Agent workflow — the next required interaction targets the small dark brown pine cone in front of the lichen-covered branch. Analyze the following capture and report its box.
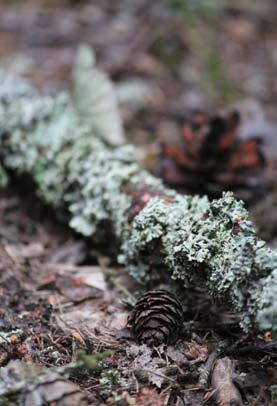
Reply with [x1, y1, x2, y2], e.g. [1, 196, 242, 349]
[128, 289, 183, 346]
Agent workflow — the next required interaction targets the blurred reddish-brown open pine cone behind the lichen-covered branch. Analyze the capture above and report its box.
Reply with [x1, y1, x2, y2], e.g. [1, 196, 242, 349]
[161, 112, 266, 200]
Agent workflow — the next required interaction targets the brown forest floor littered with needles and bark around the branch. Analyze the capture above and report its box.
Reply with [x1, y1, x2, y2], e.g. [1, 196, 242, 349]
[0, 0, 277, 406]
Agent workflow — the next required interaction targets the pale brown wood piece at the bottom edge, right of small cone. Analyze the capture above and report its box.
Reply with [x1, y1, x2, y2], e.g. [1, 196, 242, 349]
[212, 357, 240, 406]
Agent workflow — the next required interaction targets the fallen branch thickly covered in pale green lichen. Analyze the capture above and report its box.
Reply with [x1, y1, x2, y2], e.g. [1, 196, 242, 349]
[0, 46, 277, 332]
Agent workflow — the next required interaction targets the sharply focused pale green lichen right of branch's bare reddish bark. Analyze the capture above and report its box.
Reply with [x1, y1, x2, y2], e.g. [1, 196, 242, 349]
[123, 193, 277, 329]
